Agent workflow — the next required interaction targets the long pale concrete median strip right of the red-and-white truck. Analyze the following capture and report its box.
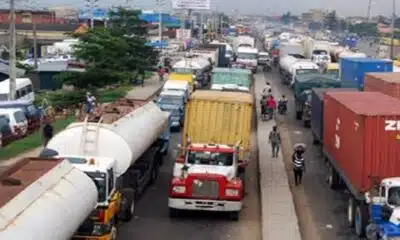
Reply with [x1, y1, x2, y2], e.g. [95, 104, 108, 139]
[255, 74, 301, 240]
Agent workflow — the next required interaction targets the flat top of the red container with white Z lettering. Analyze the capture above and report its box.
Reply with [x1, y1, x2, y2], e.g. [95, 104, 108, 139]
[326, 92, 400, 116]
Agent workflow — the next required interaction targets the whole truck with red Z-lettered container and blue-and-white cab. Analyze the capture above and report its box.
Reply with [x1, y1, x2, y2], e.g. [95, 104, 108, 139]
[323, 92, 400, 240]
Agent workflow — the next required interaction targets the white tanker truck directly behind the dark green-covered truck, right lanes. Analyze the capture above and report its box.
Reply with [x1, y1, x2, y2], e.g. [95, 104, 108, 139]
[279, 56, 320, 85]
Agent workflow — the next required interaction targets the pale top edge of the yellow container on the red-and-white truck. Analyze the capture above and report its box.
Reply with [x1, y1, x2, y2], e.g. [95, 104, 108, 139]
[190, 90, 253, 104]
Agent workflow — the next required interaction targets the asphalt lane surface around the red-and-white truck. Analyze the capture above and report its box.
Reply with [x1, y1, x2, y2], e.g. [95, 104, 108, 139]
[118, 106, 261, 240]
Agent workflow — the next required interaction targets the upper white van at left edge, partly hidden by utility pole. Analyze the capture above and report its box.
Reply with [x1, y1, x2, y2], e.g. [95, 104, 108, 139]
[0, 78, 35, 102]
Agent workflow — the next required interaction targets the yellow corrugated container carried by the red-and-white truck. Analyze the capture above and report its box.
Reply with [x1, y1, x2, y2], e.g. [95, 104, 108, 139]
[182, 90, 253, 157]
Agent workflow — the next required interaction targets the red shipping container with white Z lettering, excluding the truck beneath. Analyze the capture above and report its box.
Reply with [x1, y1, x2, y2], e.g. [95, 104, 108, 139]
[324, 92, 400, 194]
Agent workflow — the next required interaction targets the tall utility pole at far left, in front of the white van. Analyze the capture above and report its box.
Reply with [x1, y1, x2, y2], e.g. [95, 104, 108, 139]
[8, 0, 17, 100]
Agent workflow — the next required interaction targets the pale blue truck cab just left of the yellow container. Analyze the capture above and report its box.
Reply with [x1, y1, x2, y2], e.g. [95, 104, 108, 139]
[156, 90, 185, 129]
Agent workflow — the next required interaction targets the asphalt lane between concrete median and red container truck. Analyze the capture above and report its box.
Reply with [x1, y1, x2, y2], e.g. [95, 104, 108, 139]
[266, 69, 359, 240]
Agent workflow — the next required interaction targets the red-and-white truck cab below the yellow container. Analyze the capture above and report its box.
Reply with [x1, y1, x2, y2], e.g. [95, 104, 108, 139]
[168, 143, 244, 220]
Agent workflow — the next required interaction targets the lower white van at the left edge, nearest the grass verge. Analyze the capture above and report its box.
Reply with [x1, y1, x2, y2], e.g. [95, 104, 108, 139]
[0, 108, 28, 136]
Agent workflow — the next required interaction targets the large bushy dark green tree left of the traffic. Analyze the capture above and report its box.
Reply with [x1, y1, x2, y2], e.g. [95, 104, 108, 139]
[58, 8, 158, 88]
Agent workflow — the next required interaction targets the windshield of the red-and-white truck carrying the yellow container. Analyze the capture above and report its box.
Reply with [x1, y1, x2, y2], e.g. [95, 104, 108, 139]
[187, 151, 233, 166]
